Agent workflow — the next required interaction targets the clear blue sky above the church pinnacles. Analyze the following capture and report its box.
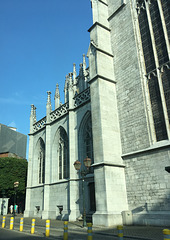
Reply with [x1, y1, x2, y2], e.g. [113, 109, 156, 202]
[0, 0, 92, 158]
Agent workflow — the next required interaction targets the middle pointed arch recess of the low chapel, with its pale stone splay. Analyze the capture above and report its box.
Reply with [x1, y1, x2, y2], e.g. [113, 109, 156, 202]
[52, 126, 69, 182]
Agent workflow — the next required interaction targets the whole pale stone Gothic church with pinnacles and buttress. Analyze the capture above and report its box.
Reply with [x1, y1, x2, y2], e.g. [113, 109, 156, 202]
[25, 0, 170, 226]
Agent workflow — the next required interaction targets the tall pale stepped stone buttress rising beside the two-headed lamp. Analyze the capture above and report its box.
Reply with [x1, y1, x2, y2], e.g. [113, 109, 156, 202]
[89, 0, 128, 226]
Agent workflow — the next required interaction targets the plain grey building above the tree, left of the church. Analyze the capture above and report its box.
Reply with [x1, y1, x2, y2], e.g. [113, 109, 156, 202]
[0, 123, 27, 158]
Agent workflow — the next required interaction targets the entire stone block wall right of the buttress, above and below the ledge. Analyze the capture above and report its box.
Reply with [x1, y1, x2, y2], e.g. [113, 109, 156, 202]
[108, 0, 170, 225]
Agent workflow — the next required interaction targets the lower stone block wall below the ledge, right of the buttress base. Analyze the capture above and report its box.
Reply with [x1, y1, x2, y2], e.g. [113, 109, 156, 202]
[124, 147, 170, 225]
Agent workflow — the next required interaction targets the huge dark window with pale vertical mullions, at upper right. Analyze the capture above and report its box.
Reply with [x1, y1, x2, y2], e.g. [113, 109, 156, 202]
[136, 0, 170, 141]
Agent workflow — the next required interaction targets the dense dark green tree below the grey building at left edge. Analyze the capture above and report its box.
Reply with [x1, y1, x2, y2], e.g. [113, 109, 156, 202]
[0, 157, 28, 212]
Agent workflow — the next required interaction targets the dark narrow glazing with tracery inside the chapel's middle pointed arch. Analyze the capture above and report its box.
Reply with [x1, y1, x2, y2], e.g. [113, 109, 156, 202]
[58, 127, 69, 179]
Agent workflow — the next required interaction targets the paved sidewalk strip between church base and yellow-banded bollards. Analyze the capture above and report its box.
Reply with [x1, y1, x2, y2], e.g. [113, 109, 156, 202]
[0, 214, 166, 240]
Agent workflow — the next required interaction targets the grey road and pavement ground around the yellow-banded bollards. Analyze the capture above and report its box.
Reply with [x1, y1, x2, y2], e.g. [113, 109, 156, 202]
[0, 215, 167, 240]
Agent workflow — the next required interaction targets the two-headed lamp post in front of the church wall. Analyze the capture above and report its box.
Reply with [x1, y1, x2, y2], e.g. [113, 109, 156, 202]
[74, 157, 91, 227]
